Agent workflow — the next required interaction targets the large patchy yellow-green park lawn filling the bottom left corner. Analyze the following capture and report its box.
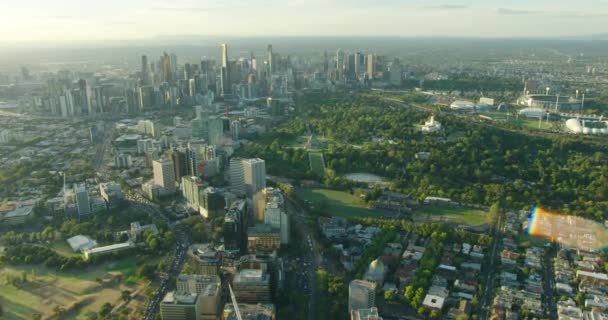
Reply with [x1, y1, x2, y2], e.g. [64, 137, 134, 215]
[0, 257, 142, 320]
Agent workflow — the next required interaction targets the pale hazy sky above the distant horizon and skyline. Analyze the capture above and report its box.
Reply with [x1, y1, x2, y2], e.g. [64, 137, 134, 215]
[0, 0, 608, 44]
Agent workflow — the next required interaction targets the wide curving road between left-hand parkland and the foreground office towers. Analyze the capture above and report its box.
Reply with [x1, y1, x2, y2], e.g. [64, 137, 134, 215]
[125, 191, 190, 320]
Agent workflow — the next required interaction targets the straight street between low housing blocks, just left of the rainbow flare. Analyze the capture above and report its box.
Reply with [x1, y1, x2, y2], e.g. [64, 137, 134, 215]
[479, 214, 505, 320]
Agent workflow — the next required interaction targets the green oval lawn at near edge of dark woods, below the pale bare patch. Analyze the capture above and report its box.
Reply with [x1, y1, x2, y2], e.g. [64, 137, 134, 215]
[296, 189, 380, 218]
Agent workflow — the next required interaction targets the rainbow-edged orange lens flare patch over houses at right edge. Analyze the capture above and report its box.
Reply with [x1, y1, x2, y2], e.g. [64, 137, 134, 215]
[526, 206, 608, 251]
